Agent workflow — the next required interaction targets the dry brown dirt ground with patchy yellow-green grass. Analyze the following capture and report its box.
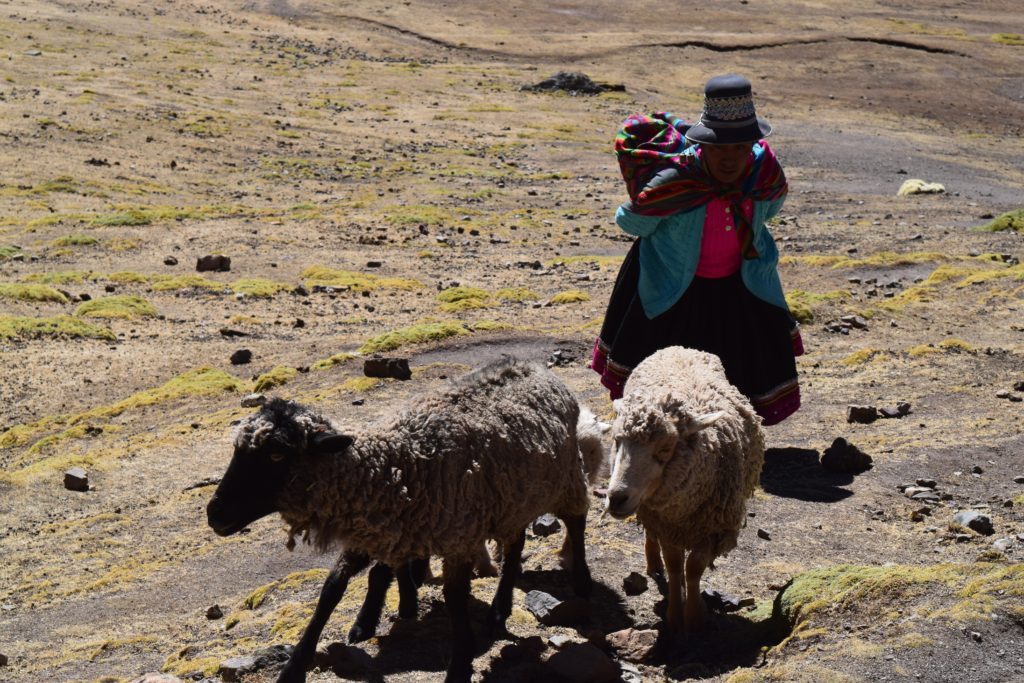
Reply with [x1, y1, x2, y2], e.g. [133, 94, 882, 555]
[0, 0, 1024, 683]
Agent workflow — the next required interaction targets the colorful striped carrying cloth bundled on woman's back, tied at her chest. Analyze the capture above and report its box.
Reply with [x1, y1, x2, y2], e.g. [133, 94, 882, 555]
[615, 112, 788, 258]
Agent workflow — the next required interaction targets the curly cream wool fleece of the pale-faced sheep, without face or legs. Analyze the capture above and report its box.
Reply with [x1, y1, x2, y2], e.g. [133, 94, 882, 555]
[615, 346, 764, 558]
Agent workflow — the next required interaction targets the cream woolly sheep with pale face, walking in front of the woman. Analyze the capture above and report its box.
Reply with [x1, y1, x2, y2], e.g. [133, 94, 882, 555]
[607, 346, 764, 632]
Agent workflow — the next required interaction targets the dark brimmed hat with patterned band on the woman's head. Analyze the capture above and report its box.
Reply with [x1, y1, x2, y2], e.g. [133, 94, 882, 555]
[686, 74, 771, 144]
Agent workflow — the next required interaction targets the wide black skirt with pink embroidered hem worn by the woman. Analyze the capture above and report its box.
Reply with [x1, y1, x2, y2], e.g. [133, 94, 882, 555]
[591, 240, 803, 425]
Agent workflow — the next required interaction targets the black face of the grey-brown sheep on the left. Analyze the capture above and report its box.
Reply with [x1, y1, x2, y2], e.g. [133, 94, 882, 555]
[206, 442, 289, 536]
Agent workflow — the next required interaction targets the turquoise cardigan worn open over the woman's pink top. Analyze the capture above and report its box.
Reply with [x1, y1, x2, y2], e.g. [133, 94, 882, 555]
[615, 197, 790, 318]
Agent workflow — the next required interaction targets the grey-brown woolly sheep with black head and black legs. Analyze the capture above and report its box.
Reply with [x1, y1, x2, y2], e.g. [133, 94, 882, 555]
[207, 357, 591, 682]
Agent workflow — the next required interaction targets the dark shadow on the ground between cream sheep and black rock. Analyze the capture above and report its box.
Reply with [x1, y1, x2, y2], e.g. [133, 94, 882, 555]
[761, 446, 853, 503]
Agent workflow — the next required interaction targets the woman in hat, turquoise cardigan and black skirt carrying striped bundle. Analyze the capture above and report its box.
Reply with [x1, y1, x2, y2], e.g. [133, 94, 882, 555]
[591, 75, 803, 425]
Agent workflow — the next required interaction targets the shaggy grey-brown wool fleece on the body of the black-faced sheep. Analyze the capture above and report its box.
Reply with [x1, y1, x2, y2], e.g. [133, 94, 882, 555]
[279, 358, 588, 565]
